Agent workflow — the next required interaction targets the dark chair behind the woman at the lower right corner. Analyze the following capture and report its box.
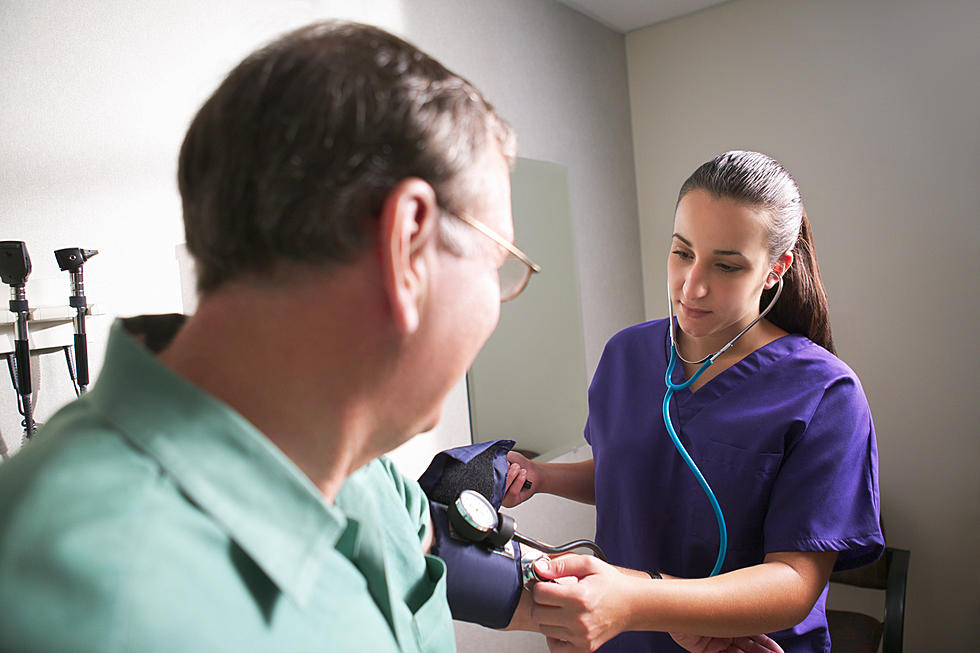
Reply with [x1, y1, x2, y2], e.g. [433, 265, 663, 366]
[827, 547, 911, 653]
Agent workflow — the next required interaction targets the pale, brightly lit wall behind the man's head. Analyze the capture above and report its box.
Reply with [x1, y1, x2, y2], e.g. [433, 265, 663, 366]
[0, 0, 642, 450]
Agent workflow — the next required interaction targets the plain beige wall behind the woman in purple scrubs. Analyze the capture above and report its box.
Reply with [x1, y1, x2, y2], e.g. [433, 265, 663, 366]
[627, 0, 980, 651]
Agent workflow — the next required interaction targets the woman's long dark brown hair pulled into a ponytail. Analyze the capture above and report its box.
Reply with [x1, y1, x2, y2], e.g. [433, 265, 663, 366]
[677, 150, 836, 353]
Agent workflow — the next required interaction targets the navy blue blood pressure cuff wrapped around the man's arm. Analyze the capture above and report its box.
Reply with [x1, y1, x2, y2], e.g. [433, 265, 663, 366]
[419, 440, 522, 628]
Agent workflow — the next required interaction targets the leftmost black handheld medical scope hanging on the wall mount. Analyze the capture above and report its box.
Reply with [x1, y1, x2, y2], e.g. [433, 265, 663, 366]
[0, 240, 34, 438]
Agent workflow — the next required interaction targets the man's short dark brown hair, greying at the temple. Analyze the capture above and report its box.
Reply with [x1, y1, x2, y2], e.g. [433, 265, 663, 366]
[177, 21, 516, 293]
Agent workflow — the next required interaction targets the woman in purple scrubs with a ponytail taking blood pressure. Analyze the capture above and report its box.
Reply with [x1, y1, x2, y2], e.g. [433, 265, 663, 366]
[504, 151, 884, 653]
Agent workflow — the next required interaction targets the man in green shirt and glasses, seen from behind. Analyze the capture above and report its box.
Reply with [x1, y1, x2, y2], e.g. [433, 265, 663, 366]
[0, 23, 530, 653]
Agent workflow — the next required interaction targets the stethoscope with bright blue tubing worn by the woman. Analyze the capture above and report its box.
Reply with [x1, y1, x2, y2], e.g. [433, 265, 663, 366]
[663, 275, 783, 576]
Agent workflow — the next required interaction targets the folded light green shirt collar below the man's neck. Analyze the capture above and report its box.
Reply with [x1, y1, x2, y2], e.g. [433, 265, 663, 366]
[85, 316, 347, 607]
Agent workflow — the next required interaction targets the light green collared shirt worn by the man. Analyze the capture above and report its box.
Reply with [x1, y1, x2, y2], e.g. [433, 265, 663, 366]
[0, 318, 455, 653]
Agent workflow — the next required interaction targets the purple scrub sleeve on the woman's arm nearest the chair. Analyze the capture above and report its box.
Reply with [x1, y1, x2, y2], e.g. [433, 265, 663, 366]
[765, 377, 884, 571]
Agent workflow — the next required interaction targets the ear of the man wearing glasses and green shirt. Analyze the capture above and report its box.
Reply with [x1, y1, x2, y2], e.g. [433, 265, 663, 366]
[378, 177, 442, 334]
